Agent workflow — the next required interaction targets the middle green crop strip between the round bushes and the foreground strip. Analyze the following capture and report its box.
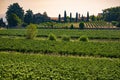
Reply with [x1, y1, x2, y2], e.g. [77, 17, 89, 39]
[0, 38, 120, 58]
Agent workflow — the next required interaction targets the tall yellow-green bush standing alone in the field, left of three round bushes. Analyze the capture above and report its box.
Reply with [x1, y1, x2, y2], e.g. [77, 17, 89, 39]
[26, 24, 37, 39]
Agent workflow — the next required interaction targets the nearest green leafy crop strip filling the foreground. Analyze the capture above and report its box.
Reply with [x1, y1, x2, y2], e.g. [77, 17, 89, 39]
[0, 52, 120, 80]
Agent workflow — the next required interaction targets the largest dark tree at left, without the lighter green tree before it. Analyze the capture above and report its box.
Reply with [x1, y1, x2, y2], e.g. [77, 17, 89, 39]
[6, 3, 24, 27]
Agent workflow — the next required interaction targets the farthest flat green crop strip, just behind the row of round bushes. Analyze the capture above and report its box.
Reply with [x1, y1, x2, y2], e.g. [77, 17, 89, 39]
[0, 29, 120, 39]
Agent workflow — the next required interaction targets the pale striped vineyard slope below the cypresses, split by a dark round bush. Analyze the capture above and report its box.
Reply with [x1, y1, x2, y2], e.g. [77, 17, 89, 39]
[38, 21, 117, 29]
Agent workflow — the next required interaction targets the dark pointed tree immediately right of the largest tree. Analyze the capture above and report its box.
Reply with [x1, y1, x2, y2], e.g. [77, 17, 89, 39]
[24, 9, 33, 24]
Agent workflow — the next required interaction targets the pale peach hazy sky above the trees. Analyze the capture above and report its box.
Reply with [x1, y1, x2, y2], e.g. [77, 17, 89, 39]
[0, 0, 120, 17]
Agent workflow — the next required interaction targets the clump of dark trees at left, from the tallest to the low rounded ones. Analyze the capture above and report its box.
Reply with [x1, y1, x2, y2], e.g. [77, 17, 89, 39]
[6, 3, 50, 27]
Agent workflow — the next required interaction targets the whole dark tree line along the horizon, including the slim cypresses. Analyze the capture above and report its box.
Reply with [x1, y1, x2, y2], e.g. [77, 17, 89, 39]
[0, 3, 120, 28]
